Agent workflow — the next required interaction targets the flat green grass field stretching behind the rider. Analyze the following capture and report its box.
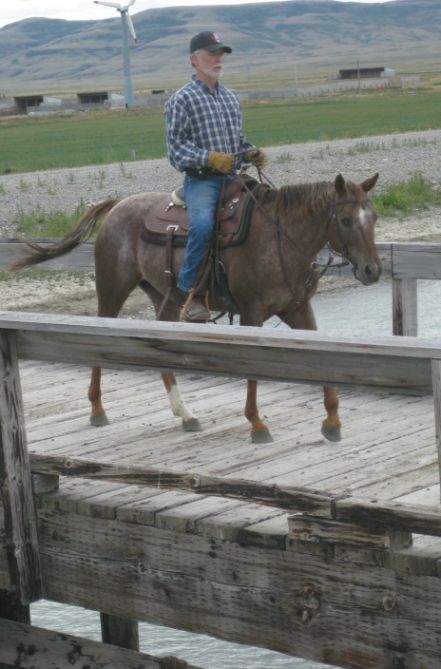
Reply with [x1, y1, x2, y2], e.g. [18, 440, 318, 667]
[0, 89, 441, 174]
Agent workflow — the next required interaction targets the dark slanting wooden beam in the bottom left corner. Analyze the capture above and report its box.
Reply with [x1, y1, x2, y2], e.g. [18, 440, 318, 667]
[0, 620, 203, 669]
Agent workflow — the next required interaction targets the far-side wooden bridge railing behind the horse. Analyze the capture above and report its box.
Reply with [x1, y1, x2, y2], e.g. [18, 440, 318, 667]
[0, 239, 441, 337]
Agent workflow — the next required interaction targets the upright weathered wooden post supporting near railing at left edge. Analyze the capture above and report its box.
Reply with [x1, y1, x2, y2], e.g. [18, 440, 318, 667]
[0, 330, 41, 605]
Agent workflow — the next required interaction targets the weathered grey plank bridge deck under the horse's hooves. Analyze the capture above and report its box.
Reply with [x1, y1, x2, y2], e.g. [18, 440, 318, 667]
[20, 361, 440, 506]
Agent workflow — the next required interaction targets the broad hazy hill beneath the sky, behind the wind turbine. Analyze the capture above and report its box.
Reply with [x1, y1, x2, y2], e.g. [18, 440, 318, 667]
[0, 0, 441, 95]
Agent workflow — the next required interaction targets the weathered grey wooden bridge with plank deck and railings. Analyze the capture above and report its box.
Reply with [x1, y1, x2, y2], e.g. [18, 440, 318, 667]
[0, 244, 441, 669]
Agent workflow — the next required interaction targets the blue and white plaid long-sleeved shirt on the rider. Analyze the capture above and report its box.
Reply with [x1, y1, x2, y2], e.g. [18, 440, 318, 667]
[165, 75, 253, 172]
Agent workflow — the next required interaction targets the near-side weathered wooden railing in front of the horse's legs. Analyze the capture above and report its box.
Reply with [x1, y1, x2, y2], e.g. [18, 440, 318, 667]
[0, 311, 441, 668]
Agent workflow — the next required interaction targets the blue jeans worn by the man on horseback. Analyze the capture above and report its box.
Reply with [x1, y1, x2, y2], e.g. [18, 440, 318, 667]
[178, 175, 234, 292]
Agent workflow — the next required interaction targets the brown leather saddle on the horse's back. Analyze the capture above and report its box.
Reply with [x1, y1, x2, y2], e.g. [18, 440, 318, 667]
[140, 174, 268, 317]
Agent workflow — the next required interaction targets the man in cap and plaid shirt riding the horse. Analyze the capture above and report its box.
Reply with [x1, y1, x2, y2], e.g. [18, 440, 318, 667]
[165, 31, 266, 321]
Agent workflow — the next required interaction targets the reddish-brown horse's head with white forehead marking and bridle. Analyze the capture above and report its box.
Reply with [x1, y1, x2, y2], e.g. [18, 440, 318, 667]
[327, 174, 383, 286]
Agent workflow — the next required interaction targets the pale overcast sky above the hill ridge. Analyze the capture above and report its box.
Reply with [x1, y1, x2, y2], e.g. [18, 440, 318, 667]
[0, 0, 393, 27]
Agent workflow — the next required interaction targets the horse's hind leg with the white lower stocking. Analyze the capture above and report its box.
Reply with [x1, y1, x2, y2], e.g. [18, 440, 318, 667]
[139, 281, 202, 432]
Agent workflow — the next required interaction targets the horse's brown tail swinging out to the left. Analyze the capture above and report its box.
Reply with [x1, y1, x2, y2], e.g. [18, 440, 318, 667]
[8, 199, 120, 272]
